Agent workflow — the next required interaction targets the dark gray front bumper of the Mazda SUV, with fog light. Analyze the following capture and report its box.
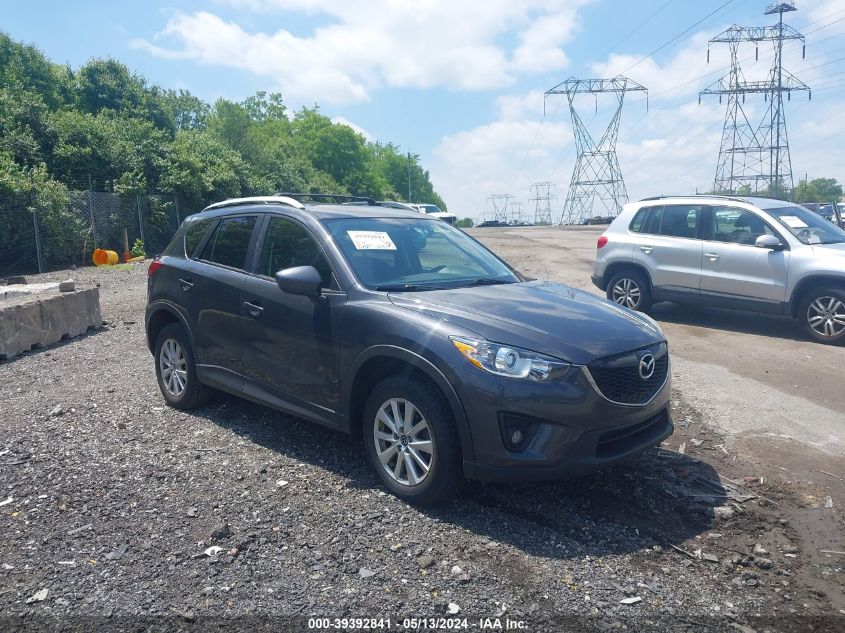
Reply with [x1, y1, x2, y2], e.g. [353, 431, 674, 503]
[458, 356, 674, 481]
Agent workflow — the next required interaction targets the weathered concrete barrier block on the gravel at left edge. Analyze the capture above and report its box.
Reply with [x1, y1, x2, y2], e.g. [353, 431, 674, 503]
[0, 288, 103, 360]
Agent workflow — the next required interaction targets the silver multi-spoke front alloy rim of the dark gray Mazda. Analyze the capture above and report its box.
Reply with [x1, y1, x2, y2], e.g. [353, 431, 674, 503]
[373, 398, 434, 486]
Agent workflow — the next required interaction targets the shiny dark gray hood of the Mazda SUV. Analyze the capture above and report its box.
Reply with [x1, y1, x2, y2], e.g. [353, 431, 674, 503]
[389, 281, 665, 365]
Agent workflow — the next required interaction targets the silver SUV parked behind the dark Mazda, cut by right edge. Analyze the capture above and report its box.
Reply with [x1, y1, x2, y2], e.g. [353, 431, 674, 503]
[592, 196, 845, 343]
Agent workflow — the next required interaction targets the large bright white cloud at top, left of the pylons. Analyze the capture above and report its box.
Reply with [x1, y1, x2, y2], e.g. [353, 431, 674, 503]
[132, 0, 590, 103]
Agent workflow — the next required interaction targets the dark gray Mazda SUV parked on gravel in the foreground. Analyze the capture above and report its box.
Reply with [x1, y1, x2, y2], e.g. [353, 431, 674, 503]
[146, 196, 673, 503]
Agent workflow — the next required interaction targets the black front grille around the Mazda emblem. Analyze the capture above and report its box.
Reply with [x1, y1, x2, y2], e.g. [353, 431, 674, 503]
[587, 343, 669, 405]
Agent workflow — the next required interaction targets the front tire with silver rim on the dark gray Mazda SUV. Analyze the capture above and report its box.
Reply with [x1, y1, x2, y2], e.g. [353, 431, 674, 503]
[362, 376, 464, 505]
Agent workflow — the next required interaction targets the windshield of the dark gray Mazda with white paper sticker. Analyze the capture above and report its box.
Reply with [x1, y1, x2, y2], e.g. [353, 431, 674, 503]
[323, 218, 521, 291]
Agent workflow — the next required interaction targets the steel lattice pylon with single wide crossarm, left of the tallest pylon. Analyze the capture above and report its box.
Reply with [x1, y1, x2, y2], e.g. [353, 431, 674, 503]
[543, 75, 648, 224]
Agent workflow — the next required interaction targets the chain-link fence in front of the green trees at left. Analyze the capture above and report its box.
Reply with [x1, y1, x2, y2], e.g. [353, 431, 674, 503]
[0, 185, 184, 278]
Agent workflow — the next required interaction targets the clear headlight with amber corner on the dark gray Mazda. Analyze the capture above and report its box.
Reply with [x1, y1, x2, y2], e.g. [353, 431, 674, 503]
[449, 336, 569, 382]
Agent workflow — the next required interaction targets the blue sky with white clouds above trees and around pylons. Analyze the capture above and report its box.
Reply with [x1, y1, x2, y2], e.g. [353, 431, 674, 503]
[0, 0, 845, 217]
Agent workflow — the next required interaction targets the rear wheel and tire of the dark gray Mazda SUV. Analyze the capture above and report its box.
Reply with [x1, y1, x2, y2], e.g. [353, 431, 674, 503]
[155, 323, 214, 409]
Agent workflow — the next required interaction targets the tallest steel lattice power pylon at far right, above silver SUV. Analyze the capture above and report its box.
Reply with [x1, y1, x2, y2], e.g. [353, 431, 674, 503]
[698, 0, 812, 198]
